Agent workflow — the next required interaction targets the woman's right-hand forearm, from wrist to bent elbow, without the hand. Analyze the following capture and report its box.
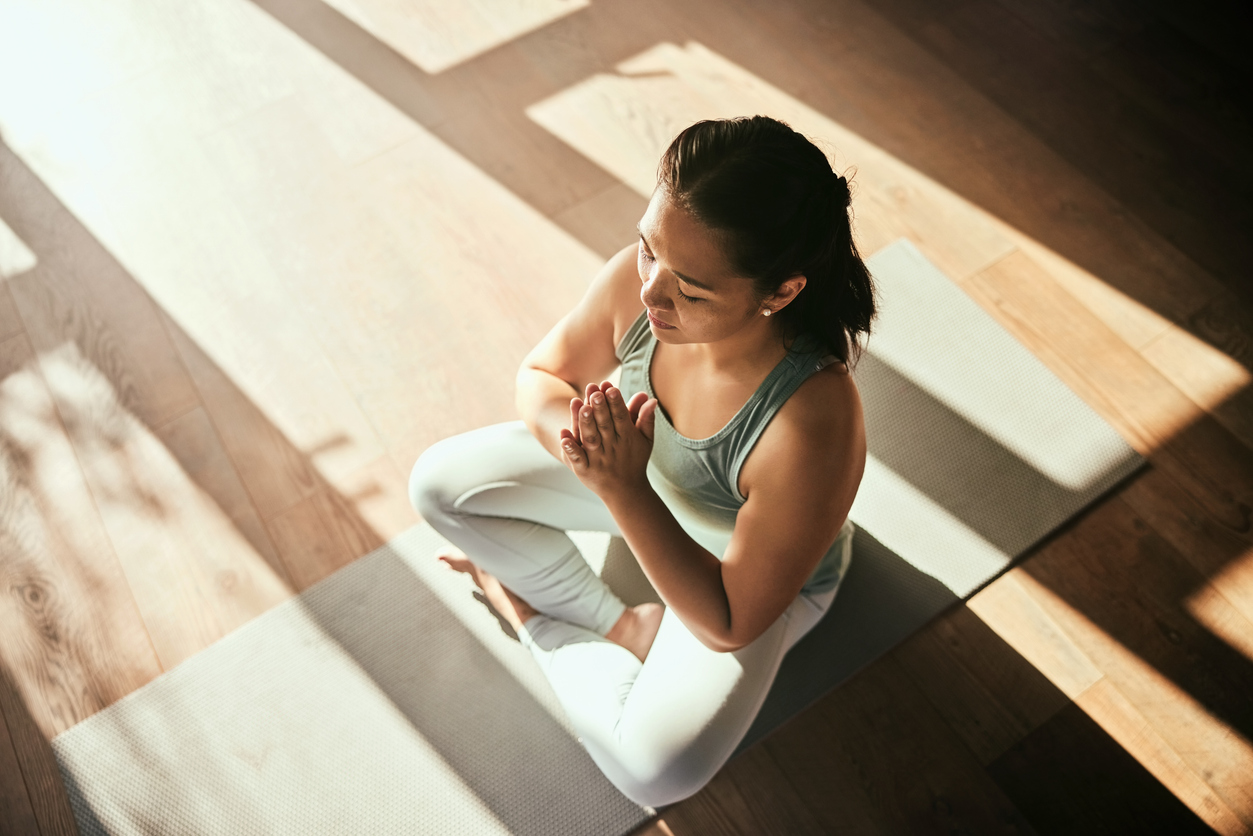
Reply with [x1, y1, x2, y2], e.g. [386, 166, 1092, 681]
[604, 483, 741, 652]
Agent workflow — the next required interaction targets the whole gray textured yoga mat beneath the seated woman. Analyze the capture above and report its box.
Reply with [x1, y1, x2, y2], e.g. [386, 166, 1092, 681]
[53, 241, 1143, 836]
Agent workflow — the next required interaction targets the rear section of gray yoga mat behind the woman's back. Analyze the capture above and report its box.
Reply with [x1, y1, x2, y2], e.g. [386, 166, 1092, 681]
[739, 239, 1144, 751]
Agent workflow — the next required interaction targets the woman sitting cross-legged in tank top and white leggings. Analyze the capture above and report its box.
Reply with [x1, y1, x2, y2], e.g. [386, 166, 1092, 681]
[410, 117, 875, 806]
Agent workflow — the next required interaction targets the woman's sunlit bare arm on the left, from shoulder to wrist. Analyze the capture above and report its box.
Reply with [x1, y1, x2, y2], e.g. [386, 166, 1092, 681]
[515, 244, 644, 459]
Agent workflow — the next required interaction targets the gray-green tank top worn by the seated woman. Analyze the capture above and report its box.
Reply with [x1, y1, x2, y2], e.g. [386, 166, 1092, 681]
[616, 312, 855, 594]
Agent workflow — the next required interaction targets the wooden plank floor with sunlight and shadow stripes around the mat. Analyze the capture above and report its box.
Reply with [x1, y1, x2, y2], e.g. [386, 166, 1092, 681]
[0, 0, 1253, 836]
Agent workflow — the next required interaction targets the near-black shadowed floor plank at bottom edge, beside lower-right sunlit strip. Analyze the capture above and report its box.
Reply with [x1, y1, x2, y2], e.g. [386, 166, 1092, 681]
[987, 704, 1213, 836]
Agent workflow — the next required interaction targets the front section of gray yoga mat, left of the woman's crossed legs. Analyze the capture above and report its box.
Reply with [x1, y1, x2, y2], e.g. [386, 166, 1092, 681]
[53, 525, 648, 836]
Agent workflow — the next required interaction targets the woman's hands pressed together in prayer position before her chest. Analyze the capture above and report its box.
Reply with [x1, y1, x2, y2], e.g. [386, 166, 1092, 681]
[561, 381, 657, 499]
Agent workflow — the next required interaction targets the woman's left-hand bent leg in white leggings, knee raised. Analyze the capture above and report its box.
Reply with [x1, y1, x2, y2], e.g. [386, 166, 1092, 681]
[408, 421, 625, 635]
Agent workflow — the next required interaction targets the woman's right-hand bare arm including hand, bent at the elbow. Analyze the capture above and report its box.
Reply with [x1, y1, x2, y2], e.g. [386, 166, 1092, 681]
[566, 372, 865, 652]
